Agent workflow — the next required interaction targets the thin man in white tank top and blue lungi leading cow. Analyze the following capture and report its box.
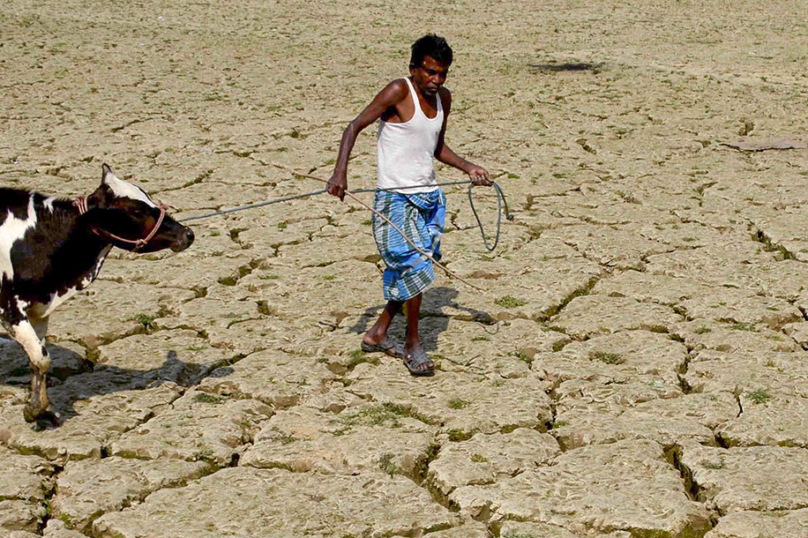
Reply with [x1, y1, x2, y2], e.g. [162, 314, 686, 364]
[328, 34, 491, 375]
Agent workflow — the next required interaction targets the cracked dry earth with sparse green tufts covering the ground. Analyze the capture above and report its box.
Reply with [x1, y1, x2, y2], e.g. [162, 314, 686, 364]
[0, 0, 808, 538]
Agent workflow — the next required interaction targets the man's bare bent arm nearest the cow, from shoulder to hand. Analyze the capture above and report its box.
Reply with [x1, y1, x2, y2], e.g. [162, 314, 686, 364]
[328, 80, 409, 200]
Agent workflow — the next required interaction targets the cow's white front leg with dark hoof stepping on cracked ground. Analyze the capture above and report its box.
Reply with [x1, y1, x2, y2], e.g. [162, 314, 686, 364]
[3, 301, 52, 422]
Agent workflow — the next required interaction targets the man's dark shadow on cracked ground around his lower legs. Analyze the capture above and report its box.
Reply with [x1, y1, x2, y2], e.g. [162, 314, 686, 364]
[349, 286, 494, 351]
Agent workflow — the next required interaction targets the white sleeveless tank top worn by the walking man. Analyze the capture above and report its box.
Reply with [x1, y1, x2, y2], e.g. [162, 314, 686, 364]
[376, 79, 443, 194]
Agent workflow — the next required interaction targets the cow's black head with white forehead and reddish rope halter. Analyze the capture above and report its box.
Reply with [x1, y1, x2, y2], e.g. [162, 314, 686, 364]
[87, 164, 194, 252]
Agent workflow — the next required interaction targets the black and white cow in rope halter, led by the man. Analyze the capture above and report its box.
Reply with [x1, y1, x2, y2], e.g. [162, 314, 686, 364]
[0, 163, 194, 424]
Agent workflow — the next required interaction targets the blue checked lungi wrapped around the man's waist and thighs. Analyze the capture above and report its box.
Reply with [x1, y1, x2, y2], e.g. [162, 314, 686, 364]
[372, 189, 446, 301]
